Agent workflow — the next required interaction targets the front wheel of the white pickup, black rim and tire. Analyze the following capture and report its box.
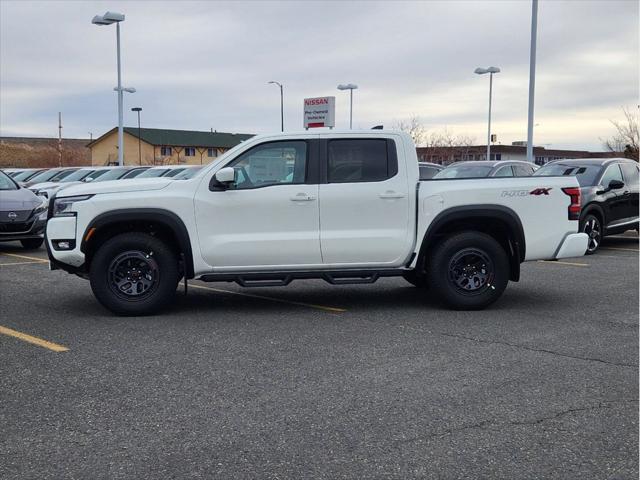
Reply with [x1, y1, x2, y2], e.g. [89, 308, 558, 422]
[89, 232, 179, 316]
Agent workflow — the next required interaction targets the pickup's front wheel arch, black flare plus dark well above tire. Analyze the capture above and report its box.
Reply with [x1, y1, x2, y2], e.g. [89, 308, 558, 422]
[80, 208, 194, 278]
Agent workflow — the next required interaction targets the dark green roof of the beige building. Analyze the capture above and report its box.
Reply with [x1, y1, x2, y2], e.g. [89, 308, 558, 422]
[87, 127, 253, 148]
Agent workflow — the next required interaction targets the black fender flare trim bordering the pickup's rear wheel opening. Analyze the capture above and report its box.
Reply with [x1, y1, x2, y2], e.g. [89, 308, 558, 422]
[419, 204, 526, 281]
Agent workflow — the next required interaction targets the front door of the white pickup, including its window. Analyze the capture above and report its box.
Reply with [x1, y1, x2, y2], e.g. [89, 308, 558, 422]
[195, 139, 322, 270]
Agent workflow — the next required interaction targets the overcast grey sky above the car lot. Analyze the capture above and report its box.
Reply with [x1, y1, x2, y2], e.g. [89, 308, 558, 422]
[0, 0, 639, 150]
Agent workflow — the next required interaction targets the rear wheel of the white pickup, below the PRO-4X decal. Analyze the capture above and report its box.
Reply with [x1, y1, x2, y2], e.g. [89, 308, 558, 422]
[427, 231, 509, 310]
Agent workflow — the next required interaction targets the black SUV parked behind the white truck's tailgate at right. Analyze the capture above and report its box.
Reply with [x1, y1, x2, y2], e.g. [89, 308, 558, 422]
[534, 158, 640, 255]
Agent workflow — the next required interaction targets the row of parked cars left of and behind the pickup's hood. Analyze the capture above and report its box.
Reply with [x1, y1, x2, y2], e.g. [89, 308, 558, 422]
[0, 165, 202, 249]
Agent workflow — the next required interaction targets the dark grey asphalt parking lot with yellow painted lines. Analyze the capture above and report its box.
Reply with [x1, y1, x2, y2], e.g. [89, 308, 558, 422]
[0, 234, 638, 479]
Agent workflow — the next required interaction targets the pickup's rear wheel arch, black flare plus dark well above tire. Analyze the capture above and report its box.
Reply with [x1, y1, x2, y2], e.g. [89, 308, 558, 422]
[417, 205, 526, 281]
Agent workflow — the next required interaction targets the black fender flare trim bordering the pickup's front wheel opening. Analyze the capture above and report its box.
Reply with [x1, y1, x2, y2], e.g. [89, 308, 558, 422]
[80, 208, 194, 278]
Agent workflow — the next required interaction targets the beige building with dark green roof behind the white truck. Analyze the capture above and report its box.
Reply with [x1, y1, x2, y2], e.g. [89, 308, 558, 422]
[87, 127, 253, 166]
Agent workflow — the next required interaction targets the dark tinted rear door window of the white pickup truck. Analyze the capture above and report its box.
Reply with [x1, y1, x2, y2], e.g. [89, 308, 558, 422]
[327, 139, 398, 183]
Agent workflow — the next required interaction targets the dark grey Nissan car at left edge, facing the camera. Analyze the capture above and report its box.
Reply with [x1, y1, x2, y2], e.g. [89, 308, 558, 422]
[0, 171, 48, 249]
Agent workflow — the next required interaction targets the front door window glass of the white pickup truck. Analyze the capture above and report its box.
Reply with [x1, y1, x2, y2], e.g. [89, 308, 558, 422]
[227, 141, 307, 190]
